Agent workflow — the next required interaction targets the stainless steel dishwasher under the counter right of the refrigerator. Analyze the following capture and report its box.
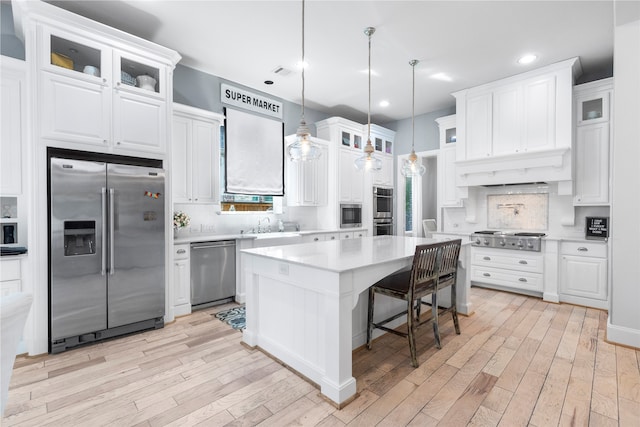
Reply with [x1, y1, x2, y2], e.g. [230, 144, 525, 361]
[191, 240, 236, 310]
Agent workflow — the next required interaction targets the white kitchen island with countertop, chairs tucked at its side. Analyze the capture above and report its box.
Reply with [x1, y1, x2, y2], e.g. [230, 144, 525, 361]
[242, 236, 470, 406]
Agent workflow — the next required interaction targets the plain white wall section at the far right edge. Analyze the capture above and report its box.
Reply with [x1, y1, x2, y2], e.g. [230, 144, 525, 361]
[607, 11, 640, 348]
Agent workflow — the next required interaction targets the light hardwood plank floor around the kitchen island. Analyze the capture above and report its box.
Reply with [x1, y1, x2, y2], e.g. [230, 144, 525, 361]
[0, 288, 640, 427]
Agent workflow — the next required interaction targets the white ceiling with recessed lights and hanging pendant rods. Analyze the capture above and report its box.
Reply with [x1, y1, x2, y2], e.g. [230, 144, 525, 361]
[43, 0, 614, 124]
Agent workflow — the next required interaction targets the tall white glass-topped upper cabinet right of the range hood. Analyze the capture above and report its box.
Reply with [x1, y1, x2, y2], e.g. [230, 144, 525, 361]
[573, 79, 613, 206]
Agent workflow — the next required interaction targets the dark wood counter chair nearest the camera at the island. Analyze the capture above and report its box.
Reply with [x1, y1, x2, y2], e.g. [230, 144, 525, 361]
[367, 243, 442, 368]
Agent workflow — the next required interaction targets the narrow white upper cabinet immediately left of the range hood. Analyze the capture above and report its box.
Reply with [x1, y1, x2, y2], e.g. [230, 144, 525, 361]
[436, 114, 462, 207]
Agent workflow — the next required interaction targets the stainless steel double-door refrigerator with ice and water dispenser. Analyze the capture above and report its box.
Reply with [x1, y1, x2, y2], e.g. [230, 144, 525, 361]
[49, 156, 165, 353]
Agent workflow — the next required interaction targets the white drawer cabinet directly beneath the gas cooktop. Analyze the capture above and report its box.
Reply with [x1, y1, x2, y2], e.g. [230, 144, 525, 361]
[471, 247, 544, 295]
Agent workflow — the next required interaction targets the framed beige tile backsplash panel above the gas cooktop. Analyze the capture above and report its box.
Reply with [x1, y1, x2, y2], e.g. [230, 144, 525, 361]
[487, 193, 549, 230]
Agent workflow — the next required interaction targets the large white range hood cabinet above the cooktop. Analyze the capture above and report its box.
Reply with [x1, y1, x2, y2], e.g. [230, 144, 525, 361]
[454, 58, 578, 186]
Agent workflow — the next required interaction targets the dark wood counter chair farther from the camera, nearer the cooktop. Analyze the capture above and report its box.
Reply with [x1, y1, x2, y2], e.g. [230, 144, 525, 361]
[416, 239, 462, 348]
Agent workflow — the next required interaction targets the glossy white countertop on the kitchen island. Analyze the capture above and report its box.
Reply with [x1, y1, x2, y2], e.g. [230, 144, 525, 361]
[242, 236, 464, 273]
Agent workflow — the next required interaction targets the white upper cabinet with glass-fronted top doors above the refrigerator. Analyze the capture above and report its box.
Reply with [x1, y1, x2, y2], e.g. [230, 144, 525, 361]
[14, 2, 180, 157]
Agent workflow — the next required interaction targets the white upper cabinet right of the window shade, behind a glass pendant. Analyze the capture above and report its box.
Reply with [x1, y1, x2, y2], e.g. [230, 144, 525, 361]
[285, 135, 329, 206]
